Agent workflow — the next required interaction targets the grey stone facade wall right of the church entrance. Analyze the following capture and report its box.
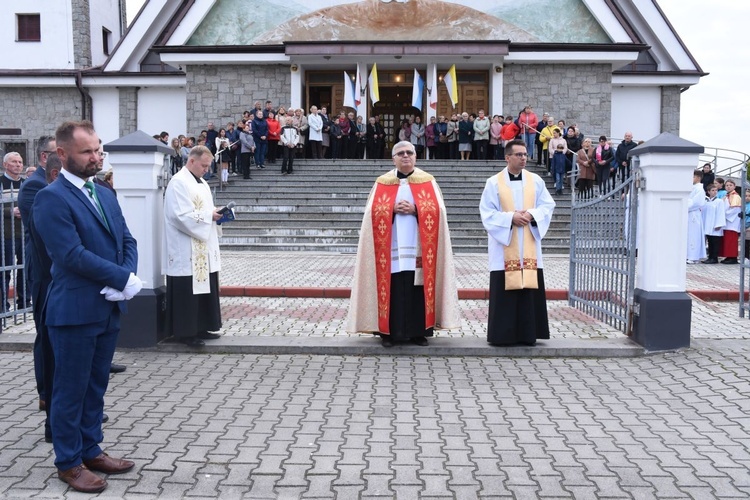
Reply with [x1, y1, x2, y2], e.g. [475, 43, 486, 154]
[503, 64, 612, 136]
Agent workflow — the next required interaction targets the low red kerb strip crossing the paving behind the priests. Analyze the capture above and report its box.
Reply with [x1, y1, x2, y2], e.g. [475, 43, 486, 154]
[219, 285, 750, 302]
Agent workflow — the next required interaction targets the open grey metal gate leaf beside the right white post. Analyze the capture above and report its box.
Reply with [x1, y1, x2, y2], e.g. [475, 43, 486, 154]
[568, 166, 640, 335]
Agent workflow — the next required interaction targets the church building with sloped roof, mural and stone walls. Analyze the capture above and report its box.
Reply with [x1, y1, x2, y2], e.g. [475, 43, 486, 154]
[0, 0, 705, 164]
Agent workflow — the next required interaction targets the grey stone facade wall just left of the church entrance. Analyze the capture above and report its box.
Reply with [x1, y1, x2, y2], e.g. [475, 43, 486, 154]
[185, 65, 291, 135]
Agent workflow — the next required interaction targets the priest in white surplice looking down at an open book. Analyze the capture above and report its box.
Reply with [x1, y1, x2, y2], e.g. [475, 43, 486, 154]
[162, 146, 221, 347]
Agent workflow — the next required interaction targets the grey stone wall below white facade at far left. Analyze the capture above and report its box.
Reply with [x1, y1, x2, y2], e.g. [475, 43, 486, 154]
[0, 87, 83, 165]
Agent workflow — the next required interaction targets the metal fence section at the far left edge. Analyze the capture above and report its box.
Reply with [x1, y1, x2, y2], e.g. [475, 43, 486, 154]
[0, 188, 31, 327]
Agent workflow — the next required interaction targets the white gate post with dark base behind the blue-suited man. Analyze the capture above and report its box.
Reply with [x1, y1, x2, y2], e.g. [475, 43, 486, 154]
[104, 130, 172, 347]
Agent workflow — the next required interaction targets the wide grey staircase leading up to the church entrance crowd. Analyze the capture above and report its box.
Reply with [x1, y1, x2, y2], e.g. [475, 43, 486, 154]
[210, 160, 571, 254]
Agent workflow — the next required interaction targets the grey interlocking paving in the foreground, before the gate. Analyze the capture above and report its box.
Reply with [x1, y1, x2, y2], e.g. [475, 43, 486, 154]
[0, 340, 750, 499]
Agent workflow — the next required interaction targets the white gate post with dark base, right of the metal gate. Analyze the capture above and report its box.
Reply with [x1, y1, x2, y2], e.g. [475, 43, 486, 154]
[628, 132, 703, 351]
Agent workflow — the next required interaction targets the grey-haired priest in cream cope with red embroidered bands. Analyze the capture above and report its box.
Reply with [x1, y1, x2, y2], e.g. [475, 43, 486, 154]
[347, 141, 461, 347]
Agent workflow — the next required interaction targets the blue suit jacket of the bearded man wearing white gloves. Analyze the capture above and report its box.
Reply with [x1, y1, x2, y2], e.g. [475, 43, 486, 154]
[33, 175, 138, 326]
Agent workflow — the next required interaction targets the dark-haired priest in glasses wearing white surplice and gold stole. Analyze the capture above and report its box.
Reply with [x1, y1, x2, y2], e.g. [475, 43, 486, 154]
[479, 140, 555, 345]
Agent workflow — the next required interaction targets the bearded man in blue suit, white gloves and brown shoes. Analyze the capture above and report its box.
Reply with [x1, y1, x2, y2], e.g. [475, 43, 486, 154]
[33, 121, 142, 493]
